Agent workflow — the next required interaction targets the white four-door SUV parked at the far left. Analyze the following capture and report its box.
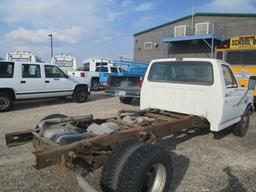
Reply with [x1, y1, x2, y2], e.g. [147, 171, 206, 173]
[0, 61, 90, 112]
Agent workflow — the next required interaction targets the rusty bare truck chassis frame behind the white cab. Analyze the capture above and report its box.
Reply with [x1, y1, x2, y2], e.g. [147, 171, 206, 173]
[6, 109, 209, 191]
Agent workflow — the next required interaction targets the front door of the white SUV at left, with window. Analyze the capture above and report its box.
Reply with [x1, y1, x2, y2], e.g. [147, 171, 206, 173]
[44, 65, 75, 96]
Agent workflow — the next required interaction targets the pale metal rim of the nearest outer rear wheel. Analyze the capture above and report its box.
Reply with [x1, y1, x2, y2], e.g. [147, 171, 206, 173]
[141, 163, 166, 192]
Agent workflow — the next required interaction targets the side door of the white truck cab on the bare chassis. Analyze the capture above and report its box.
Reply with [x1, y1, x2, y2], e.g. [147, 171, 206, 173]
[222, 64, 245, 123]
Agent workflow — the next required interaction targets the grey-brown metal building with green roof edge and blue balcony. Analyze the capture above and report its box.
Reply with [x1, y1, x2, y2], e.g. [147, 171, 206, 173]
[134, 13, 256, 61]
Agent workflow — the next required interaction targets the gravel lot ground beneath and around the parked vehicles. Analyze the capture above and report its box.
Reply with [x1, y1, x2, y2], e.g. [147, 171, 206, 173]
[0, 92, 256, 192]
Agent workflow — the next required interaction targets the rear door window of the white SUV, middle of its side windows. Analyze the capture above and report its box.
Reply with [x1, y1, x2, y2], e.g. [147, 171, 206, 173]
[21, 64, 41, 78]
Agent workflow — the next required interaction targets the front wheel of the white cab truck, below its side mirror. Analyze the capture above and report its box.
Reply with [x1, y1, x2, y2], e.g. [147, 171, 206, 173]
[233, 107, 250, 137]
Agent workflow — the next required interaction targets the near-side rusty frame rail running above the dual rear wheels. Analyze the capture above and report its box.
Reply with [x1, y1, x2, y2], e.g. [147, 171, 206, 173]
[34, 116, 207, 169]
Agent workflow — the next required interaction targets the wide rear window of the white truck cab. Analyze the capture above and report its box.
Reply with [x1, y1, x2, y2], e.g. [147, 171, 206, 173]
[148, 61, 213, 85]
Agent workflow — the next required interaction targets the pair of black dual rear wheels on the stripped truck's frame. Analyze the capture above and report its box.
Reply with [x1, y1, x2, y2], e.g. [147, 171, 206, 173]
[101, 141, 172, 192]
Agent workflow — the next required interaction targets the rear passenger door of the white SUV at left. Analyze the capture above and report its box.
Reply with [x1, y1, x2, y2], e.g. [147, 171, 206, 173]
[17, 64, 45, 98]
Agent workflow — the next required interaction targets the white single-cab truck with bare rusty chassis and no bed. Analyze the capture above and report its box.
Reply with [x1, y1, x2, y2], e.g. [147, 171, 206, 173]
[6, 58, 256, 192]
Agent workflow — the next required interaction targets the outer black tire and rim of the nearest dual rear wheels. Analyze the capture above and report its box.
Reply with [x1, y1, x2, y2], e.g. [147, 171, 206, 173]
[117, 144, 172, 192]
